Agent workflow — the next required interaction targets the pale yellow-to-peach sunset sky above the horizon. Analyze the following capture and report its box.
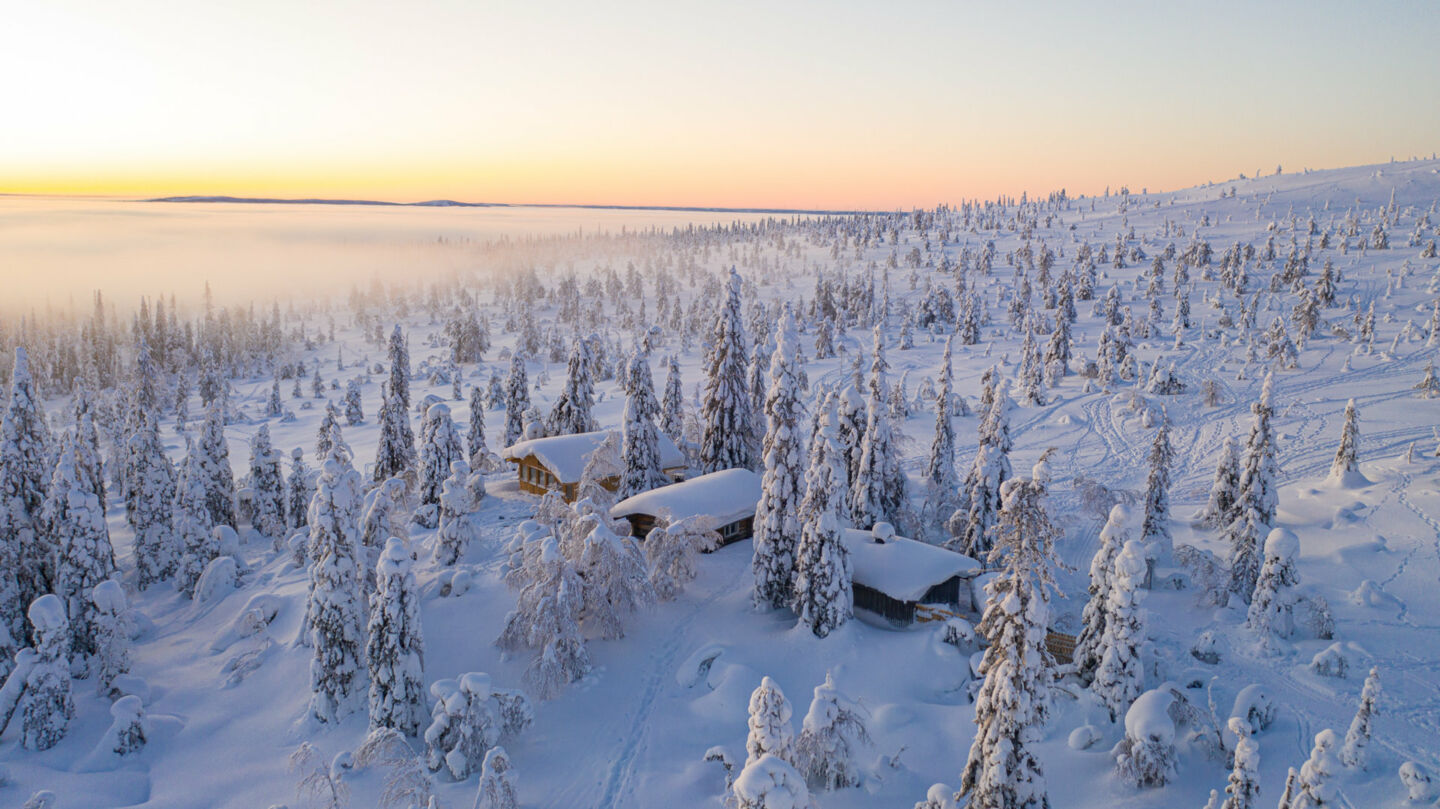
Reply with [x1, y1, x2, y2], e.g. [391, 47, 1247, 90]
[0, 0, 1440, 209]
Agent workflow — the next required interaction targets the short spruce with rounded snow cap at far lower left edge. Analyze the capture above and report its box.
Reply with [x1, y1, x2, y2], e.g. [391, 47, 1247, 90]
[19, 595, 75, 750]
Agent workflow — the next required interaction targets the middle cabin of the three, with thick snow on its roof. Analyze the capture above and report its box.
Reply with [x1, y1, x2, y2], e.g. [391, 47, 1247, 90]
[611, 469, 760, 546]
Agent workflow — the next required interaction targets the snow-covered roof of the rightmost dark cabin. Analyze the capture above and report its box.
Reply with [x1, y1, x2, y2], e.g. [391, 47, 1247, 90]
[840, 528, 981, 602]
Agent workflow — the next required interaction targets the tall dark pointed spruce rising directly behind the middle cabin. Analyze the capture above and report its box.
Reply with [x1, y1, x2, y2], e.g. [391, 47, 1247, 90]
[700, 268, 755, 472]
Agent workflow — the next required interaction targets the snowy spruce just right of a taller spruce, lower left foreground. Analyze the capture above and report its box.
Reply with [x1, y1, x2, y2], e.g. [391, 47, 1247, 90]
[366, 537, 425, 736]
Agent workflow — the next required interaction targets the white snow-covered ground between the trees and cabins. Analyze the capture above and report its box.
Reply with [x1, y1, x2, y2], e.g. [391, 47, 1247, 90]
[0, 160, 1440, 809]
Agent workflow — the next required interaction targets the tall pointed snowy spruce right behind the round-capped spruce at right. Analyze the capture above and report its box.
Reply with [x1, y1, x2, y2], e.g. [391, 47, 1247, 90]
[1225, 371, 1279, 599]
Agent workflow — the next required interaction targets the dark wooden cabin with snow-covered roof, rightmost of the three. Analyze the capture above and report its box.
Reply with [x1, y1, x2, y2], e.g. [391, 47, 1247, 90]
[841, 523, 981, 623]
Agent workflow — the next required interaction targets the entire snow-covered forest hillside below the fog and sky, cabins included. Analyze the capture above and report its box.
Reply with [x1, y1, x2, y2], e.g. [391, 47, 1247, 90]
[0, 158, 1440, 809]
